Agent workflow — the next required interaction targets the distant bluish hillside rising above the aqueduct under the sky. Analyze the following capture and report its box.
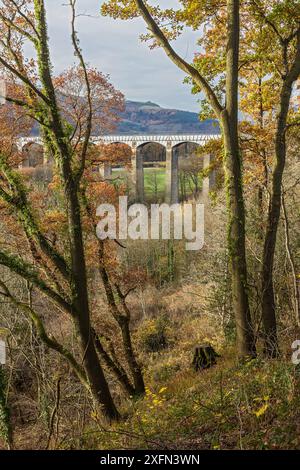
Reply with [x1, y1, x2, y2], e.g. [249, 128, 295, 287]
[115, 101, 219, 134]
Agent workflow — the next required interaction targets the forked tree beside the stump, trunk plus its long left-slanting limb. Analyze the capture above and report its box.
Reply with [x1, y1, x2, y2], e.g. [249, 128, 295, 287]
[135, 0, 256, 357]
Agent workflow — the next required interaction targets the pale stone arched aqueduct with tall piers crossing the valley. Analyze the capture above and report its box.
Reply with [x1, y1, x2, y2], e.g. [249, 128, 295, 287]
[18, 134, 219, 203]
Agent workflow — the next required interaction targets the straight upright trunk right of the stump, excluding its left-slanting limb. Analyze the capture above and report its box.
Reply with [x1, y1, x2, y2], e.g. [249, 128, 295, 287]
[221, 0, 255, 357]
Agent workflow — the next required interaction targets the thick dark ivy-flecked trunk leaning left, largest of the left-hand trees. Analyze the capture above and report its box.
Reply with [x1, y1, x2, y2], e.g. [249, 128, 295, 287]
[34, 0, 119, 420]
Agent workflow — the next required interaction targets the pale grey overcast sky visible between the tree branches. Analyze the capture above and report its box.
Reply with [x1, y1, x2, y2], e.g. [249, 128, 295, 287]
[46, 0, 198, 111]
